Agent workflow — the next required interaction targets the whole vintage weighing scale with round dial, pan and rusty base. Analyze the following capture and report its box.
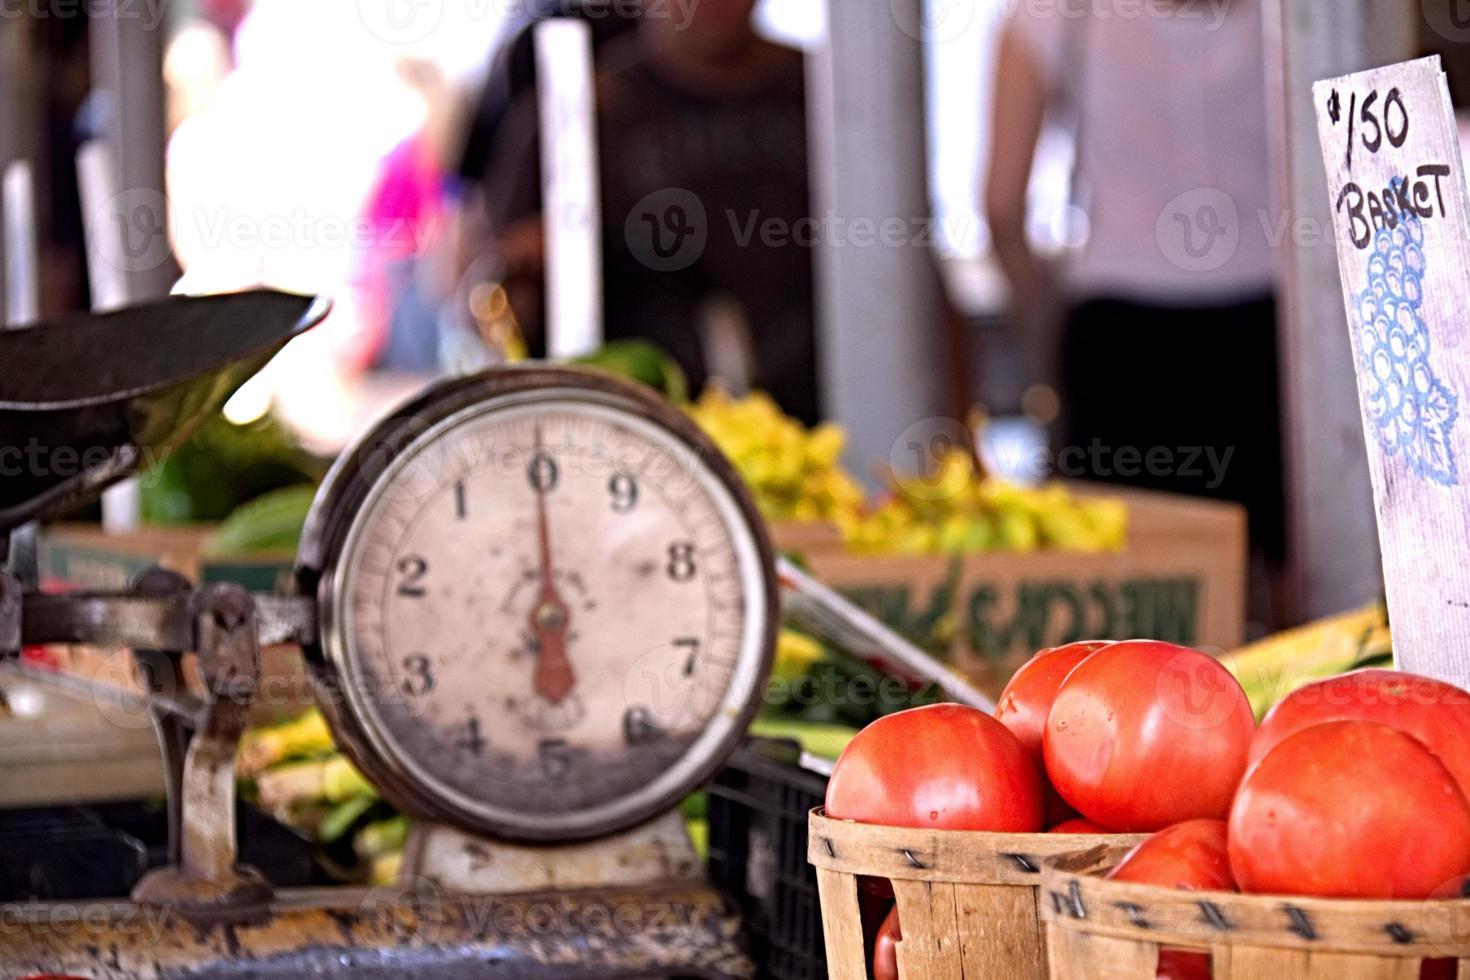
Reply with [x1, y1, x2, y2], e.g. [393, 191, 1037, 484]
[0, 291, 973, 977]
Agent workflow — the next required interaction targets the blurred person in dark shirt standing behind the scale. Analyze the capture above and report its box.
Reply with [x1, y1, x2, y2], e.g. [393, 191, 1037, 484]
[484, 0, 819, 422]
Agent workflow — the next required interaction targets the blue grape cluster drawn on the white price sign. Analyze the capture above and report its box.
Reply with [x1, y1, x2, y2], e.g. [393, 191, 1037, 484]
[1357, 181, 1460, 486]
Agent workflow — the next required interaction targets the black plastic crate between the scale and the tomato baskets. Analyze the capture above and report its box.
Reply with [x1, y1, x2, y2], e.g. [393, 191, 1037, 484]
[709, 739, 828, 980]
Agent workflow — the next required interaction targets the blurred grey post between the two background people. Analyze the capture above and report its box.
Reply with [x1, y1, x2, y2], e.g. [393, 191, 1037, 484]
[807, 0, 942, 473]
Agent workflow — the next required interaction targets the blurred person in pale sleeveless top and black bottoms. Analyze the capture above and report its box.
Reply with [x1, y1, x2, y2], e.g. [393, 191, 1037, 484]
[985, 0, 1285, 581]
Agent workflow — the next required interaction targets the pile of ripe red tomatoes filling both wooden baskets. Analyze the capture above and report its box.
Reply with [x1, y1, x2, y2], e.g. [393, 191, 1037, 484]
[826, 641, 1470, 980]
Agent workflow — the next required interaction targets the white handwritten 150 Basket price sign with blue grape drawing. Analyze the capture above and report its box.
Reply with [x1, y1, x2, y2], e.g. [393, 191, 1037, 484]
[1313, 57, 1470, 686]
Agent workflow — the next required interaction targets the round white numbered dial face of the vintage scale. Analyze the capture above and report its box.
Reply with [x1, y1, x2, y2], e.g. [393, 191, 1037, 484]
[316, 388, 772, 839]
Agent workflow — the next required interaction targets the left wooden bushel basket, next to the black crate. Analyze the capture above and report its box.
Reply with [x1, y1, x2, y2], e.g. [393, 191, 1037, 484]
[807, 808, 1152, 980]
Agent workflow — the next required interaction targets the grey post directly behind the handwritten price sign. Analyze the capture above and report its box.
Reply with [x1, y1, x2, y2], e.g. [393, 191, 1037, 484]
[1266, 0, 1419, 620]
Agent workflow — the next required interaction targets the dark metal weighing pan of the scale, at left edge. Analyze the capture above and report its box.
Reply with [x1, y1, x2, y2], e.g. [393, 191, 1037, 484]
[0, 289, 331, 537]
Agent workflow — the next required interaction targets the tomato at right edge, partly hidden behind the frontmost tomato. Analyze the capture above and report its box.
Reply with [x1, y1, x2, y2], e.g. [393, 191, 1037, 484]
[1251, 670, 1470, 798]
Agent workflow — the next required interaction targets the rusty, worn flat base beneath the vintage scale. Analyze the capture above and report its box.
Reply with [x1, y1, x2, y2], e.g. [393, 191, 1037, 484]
[0, 883, 756, 980]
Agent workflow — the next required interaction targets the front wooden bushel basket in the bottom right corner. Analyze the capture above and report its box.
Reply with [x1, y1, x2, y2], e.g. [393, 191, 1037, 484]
[1042, 846, 1470, 980]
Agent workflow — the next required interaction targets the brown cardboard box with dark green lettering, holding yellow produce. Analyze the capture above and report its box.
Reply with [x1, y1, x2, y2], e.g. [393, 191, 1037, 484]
[775, 488, 1247, 695]
